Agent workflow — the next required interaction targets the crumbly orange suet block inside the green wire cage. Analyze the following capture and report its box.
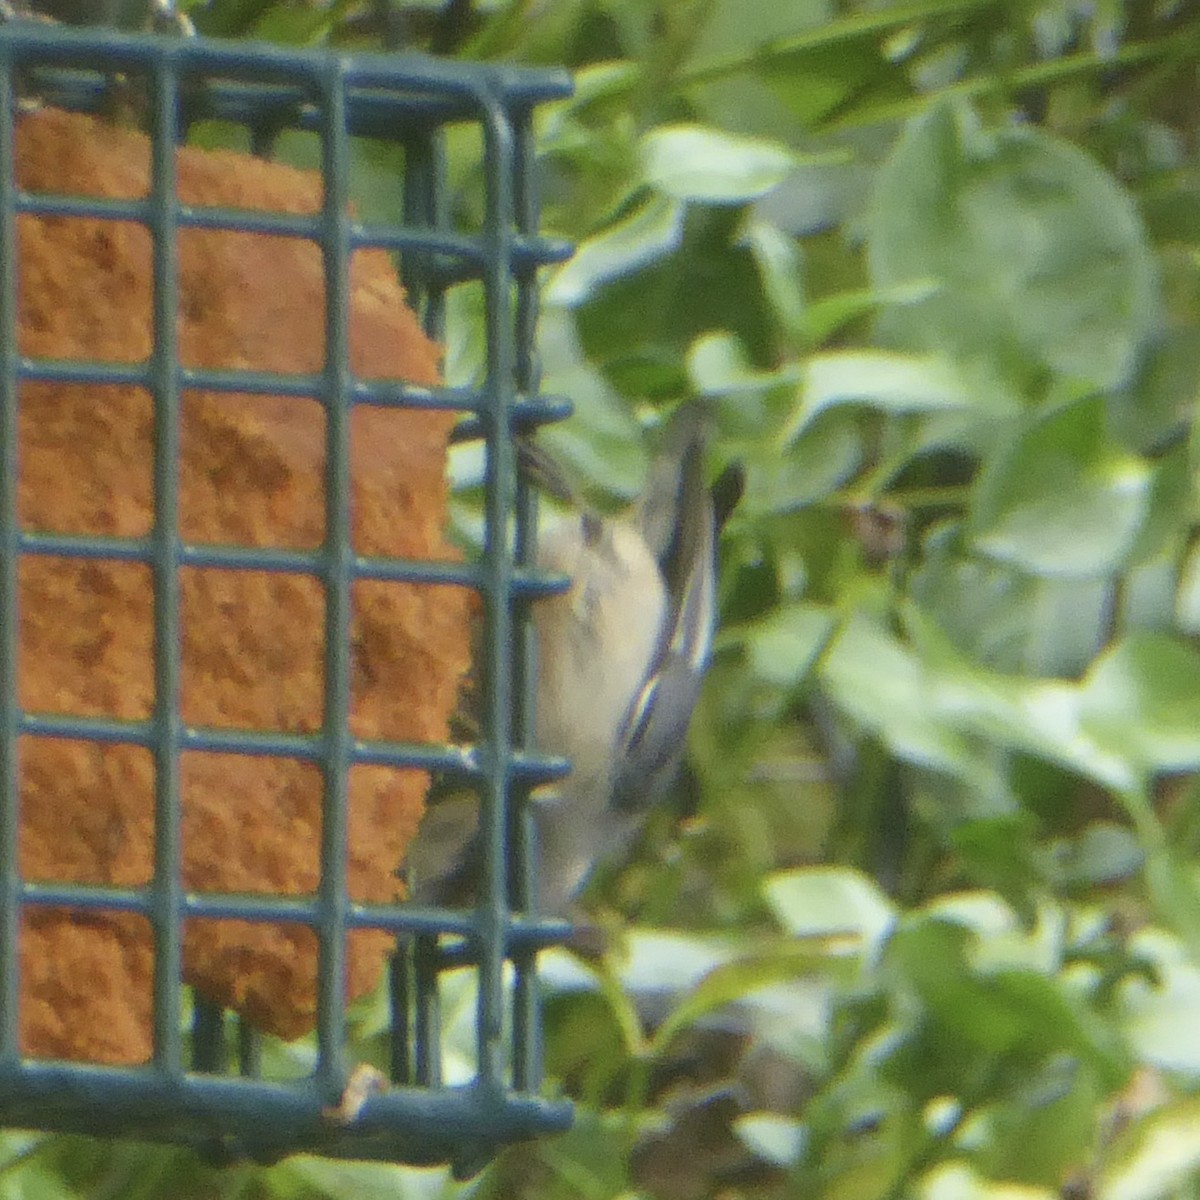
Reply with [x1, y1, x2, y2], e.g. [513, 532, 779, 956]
[16, 109, 470, 1062]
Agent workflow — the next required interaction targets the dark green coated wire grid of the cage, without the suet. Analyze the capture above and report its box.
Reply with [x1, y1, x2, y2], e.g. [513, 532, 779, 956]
[0, 14, 570, 1175]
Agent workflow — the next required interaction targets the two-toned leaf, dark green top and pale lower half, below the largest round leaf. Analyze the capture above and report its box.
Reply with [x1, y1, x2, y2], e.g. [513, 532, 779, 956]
[968, 398, 1154, 577]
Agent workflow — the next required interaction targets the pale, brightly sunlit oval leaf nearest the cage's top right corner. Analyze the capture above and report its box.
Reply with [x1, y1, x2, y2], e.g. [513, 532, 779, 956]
[640, 125, 802, 204]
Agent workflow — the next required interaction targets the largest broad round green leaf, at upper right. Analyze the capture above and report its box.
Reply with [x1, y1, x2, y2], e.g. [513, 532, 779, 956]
[869, 104, 1158, 389]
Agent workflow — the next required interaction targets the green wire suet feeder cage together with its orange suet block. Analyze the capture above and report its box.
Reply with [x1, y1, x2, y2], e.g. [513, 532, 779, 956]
[0, 4, 570, 1175]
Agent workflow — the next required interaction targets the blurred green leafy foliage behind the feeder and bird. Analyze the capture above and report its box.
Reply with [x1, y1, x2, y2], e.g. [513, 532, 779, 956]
[11, 0, 1200, 1200]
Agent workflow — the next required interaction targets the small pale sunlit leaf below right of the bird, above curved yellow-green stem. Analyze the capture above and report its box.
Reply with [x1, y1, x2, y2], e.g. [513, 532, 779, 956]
[763, 866, 896, 953]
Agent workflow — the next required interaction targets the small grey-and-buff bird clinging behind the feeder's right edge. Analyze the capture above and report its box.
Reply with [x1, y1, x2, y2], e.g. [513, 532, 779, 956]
[409, 404, 743, 917]
